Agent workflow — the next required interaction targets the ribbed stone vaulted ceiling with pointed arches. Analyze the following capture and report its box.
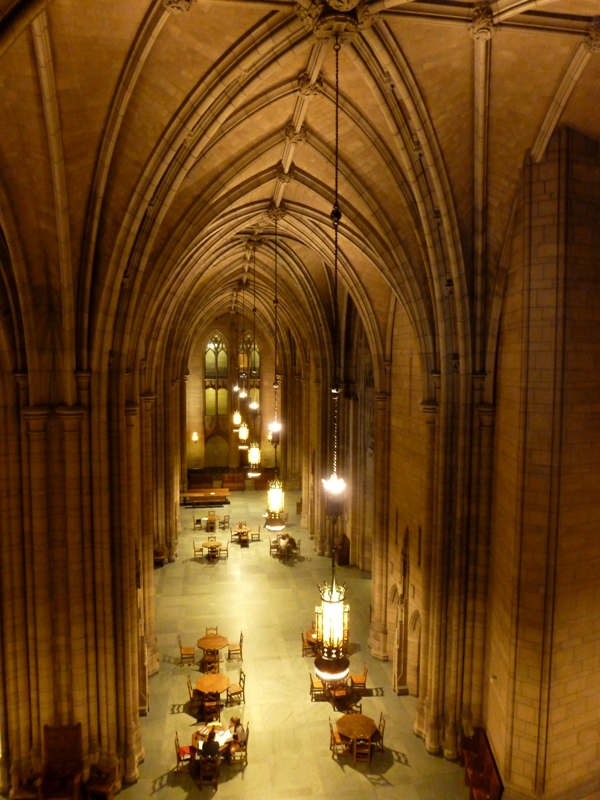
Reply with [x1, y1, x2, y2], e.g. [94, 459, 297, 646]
[0, 0, 600, 394]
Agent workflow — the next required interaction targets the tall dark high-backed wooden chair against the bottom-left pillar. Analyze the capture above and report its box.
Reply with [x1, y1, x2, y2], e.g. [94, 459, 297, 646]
[38, 722, 83, 800]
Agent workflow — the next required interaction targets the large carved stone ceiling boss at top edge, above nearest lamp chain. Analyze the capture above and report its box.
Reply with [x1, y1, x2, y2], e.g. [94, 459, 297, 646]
[296, 0, 376, 41]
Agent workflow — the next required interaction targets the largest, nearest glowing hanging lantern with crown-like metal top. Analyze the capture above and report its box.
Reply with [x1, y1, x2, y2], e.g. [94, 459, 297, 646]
[315, 569, 350, 681]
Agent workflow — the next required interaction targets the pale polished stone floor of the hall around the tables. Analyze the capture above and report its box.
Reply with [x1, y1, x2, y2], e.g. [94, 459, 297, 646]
[122, 491, 468, 800]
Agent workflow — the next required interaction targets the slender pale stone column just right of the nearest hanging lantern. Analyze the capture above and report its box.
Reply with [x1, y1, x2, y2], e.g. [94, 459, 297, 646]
[369, 392, 390, 661]
